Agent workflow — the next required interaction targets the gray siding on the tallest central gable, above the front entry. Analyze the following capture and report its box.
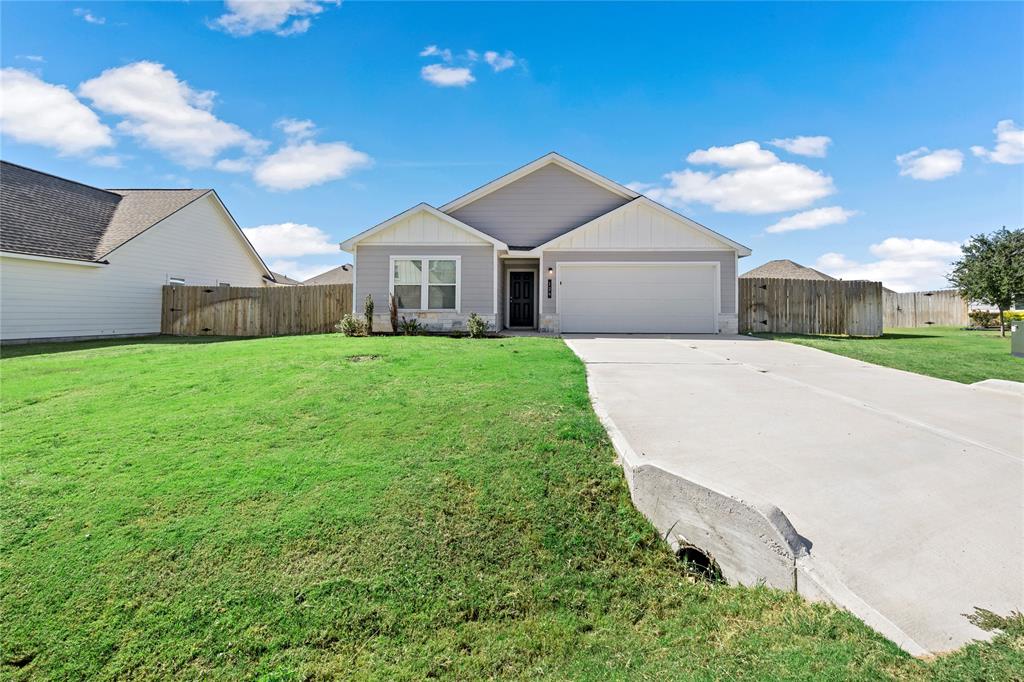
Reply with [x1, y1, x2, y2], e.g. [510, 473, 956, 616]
[452, 164, 629, 247]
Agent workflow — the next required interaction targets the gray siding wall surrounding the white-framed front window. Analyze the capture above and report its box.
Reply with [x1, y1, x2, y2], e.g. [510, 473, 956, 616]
[354, 245, 495, 315]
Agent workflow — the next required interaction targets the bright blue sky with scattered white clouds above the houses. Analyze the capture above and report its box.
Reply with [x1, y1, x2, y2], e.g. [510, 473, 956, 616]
[0, 0, 1024, 289]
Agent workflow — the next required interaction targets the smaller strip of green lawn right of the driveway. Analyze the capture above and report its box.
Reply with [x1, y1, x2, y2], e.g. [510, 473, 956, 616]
[758, 327, 1024, 384]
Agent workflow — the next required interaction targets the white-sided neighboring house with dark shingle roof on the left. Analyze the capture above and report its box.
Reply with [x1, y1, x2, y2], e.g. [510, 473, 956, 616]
[0, 162, 273, 342]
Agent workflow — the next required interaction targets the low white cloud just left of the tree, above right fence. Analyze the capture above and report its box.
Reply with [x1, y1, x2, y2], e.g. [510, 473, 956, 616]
[814, 237, 961, 291]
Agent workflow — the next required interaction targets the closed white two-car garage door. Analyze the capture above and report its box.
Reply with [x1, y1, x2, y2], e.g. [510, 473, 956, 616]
[557, 263, 718, 334]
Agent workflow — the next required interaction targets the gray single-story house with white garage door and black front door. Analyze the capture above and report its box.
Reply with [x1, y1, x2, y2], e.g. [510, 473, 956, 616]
[341, 153, 751, 334]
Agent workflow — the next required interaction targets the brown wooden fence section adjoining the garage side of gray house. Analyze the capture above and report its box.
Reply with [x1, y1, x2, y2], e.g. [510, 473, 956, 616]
[739, 278, 882, 336]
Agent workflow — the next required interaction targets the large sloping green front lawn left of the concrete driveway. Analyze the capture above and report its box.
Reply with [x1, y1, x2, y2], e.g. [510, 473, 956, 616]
[0, 335, 1024, 680]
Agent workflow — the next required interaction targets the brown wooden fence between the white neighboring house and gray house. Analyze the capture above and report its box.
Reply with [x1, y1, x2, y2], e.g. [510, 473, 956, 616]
[160, 284, 352, 336]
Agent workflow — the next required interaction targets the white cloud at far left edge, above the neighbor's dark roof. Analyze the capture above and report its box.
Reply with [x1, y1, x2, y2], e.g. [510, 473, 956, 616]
[0, 69, 114, 155]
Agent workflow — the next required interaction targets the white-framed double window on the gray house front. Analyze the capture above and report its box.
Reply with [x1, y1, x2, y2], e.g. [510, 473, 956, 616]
[391, 256, 461, 310]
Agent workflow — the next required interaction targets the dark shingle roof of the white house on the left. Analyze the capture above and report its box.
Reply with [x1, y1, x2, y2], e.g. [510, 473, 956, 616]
[0, 161, 212, 261]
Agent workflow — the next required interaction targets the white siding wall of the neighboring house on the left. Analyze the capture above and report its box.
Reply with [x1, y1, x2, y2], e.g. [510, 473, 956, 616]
[0, 195, 265, 341]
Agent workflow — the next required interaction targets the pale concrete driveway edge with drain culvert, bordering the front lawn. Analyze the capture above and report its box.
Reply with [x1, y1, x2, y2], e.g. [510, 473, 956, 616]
[570, 358, 930, 656]
